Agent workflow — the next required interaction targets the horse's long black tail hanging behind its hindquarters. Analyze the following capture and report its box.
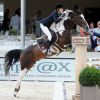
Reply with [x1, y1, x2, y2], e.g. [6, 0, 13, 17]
[4, 49, 22, 75]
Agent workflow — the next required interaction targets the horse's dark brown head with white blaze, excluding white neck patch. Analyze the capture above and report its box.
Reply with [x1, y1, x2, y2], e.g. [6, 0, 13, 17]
[64, 9, 89, 32]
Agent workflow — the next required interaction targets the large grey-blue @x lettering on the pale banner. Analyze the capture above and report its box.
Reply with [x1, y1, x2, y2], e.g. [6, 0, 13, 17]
[37, 62, 70, 73]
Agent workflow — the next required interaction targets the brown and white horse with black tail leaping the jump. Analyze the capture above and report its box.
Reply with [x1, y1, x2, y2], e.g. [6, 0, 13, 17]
[4, 9, 88, 97]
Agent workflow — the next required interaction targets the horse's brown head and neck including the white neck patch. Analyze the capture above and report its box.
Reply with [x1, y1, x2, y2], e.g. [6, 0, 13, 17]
[50, 9, 89, 35]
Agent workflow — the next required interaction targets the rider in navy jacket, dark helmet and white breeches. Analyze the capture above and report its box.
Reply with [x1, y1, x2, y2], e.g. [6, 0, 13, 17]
[40, 4, 65, 43]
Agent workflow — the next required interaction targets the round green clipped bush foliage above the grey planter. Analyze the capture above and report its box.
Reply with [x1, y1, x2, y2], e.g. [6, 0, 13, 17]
[79, 66, 100, 87]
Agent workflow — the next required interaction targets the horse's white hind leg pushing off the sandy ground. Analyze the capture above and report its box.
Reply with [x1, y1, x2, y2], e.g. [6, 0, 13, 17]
[14, 68, 28, 97]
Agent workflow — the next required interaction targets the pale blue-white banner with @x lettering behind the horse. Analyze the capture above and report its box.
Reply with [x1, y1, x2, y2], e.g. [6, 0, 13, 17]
[0, 58, 75, 81]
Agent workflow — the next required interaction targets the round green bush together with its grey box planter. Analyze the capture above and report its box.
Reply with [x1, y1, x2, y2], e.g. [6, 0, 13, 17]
[79, 66, 100, 100]
